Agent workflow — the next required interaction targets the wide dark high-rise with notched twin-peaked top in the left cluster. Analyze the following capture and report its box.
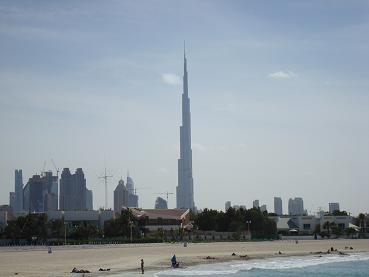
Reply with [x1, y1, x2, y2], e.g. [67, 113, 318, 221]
[59, 168, 87, 211]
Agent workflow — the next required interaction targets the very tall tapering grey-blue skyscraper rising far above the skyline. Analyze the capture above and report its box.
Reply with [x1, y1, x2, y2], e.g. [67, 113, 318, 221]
[177, 46, 196, 210]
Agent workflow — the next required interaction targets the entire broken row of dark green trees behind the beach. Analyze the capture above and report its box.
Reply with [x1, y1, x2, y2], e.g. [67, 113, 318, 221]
[0, 208, 366, 242]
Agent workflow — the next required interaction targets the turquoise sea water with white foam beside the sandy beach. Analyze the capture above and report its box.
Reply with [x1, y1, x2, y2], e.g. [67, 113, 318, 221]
[150, 253, 369, 277]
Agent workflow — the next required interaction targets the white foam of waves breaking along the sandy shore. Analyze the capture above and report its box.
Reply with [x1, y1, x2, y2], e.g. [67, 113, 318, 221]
[154, 253, 369, 277]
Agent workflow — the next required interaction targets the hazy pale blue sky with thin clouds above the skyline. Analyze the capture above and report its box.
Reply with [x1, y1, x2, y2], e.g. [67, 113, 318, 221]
[0, 0, 369, 214]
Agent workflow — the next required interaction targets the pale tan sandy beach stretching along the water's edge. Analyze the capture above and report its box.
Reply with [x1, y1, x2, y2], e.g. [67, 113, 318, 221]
[0, 239, 369, 277]
